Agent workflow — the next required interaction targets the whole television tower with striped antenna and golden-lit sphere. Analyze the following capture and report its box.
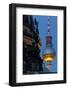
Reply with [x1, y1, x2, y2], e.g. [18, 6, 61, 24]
[43, 16, 55, 71]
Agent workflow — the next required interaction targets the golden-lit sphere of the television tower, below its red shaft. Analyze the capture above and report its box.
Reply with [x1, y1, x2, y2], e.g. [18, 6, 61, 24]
[43, 47, 55, 62]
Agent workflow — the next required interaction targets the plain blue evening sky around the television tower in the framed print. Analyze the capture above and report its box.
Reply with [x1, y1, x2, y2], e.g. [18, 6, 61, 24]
[33, 15, 57, 72]
